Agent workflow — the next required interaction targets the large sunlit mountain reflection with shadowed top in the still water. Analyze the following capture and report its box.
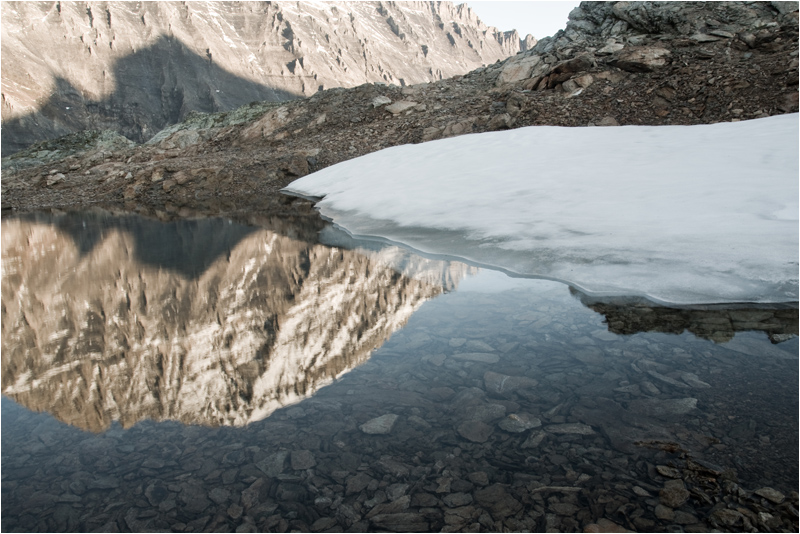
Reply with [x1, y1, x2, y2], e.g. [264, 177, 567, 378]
[2, 211, 464, 431]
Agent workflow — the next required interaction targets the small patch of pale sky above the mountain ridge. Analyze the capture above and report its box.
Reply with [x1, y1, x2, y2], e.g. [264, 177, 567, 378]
[464, 0, 580, 39]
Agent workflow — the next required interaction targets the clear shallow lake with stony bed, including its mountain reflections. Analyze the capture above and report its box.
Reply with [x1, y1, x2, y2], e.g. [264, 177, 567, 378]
[2, 214, 798, 531]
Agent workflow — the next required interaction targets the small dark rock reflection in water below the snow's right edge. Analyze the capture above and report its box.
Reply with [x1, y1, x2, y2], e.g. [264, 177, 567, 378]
[570, 288, 798, 343]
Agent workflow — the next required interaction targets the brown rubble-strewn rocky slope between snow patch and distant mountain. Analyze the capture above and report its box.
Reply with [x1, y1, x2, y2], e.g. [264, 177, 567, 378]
[2, 2, 798, 217]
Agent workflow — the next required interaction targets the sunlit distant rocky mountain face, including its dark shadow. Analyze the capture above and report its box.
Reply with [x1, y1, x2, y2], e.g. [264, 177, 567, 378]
[2, 2, 535, 155]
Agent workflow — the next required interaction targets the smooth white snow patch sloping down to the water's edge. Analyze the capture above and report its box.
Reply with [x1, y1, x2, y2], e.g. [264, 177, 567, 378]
[284, 114, 800, 304]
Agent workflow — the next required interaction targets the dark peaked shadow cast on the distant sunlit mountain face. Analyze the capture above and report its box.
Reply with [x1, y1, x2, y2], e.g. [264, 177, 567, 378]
[2, 36, 301, 157]
